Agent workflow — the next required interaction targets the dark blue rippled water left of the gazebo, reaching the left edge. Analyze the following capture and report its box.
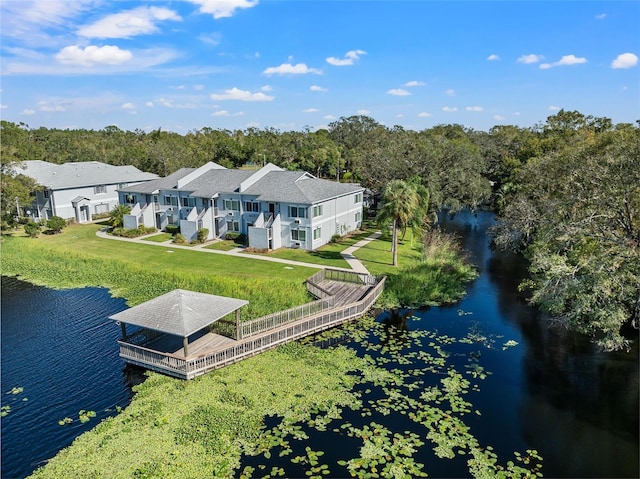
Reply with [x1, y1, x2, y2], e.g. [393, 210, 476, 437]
[1, 277, 142, 479]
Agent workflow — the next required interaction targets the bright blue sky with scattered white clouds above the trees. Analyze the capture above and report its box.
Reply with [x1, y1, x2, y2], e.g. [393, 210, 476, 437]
[0, 0, 640, 133]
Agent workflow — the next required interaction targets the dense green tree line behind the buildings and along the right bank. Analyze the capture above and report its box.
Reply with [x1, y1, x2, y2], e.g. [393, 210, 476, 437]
[0, 110, 640, 350]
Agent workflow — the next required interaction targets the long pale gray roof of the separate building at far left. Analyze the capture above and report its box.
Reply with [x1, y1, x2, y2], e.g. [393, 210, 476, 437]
[18, 160, 158, 190]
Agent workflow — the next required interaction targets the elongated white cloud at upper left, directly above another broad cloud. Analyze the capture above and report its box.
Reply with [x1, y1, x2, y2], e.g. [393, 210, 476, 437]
[78, 6, 182, 38]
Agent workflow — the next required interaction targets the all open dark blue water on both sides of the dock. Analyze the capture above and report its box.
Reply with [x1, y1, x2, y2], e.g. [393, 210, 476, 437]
[2, 212, 639, 478]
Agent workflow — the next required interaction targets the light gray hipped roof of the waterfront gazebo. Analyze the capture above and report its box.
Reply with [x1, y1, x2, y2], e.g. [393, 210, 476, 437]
[109, 289, 249, 338]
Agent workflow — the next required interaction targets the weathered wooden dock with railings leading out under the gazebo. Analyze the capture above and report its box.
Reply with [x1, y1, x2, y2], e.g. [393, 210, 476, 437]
[118, 269, 385, 379]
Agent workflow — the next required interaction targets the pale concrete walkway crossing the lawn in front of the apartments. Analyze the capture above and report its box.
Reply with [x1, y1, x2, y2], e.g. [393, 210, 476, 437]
[96, 228, 382, 274]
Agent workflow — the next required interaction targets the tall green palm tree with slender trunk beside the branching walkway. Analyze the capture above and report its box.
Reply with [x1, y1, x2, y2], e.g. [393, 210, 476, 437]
[378, 180, 420, 266]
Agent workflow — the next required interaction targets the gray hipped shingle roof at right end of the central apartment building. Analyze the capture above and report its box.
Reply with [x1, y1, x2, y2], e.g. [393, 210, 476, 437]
[243, 171, 364, 204]
